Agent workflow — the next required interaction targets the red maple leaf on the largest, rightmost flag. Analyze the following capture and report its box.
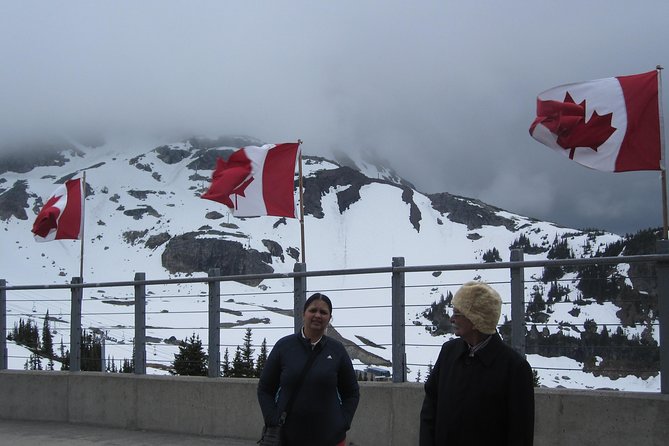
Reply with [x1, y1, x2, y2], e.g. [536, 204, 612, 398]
[533, 92, 616, 159]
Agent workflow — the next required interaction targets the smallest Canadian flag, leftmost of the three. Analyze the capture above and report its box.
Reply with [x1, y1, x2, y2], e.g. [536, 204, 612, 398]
[32, 178, 84, 242]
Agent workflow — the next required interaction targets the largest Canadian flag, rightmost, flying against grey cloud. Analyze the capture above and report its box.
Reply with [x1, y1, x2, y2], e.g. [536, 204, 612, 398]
[530, 71, 661, 172]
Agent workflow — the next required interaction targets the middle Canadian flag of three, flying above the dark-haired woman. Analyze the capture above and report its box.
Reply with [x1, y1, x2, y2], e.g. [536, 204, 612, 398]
[201, 143, 299, 218]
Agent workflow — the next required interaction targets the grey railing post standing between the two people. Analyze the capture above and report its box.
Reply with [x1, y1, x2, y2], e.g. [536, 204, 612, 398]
[392, 257, 407, 383]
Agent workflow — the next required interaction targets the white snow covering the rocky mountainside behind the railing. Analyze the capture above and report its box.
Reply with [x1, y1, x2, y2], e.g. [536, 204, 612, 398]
[0, 141, 660, 392]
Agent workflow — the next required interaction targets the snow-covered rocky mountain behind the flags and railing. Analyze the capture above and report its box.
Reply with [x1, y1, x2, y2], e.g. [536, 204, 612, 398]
[0, 137, 659, 391]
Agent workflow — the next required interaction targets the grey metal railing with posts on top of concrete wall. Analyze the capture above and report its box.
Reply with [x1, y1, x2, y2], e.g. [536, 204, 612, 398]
[0, 244, 669, 393]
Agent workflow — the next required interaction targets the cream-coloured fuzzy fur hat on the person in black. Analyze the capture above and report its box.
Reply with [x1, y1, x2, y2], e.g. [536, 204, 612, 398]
[453, 282, 502, 334]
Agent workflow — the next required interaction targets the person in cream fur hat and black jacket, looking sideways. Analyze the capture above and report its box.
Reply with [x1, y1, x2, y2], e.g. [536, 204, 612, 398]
[419, 282, 534, 446]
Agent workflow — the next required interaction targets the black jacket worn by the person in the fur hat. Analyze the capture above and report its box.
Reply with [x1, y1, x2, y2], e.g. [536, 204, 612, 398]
[420, 333, 534, 446]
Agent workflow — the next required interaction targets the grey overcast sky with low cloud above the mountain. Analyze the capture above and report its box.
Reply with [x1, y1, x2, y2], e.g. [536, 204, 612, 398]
[0, 0, 669, 234]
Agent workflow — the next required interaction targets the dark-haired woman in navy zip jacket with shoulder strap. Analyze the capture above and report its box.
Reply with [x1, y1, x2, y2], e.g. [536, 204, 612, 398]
[258, 293, 360, 446]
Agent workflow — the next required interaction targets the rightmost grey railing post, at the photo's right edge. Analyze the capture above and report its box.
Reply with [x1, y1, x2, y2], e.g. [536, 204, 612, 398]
[655, 240, 669, 394]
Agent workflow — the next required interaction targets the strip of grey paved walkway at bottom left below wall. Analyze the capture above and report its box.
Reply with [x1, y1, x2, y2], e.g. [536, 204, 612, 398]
[0, 419, 257, 446]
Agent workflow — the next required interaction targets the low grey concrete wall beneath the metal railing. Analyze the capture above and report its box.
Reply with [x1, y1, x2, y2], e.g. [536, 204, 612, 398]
[0, 370, 669, 446]
